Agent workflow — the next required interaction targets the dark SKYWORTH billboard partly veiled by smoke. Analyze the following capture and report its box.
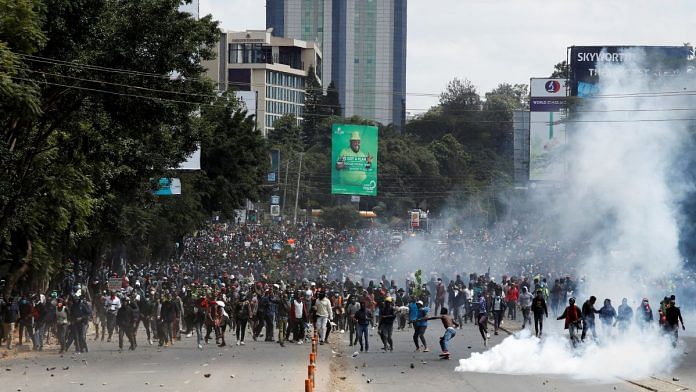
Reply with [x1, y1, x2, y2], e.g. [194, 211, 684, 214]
[568, 46, 689, 97]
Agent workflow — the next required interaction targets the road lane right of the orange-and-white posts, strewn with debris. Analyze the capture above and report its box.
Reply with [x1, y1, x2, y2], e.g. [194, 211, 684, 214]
[324, 316, 696, 392]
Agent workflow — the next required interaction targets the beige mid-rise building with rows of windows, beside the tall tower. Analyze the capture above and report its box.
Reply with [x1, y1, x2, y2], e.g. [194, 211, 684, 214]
[203, 30, 322, 136]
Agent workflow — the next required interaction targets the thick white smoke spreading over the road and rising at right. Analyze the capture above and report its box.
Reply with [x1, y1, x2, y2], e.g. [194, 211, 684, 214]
[456, 48, 694, 380]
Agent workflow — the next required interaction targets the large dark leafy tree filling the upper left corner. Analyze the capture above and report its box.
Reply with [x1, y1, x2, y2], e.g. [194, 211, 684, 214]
[0, 0, 223, 292]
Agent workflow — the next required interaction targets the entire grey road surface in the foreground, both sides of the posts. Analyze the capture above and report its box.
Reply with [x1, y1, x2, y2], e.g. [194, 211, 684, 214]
[0, 322, 696, 392]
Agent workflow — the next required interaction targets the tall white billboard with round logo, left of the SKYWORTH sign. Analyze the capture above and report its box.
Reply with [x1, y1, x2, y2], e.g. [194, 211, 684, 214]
[529, 78, 566, 181]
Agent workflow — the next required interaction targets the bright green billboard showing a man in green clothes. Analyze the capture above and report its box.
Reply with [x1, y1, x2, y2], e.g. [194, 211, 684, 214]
[331, 124, 378, 196]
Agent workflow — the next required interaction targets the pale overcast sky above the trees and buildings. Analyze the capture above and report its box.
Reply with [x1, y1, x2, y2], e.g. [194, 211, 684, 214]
[200, 0, 696, 112]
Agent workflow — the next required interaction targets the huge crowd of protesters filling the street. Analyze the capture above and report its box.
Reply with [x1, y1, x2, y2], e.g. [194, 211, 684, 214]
[0, 223, 694, 356]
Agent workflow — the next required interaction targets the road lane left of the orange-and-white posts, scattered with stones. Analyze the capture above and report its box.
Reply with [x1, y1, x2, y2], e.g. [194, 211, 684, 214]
[0, 328, 330, 392]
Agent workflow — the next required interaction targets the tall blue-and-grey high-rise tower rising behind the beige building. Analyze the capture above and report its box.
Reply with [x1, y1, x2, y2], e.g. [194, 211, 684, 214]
[266, 0, 406, 128]
